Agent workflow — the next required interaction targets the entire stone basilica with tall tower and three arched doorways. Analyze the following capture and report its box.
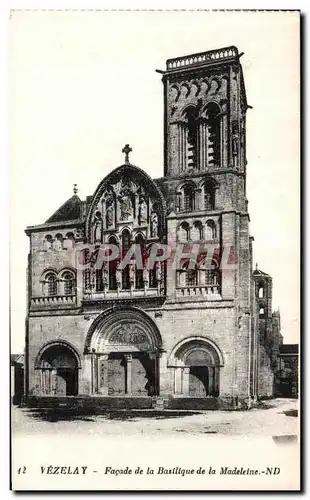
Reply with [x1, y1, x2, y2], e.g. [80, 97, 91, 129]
[25, 47, 281, 408]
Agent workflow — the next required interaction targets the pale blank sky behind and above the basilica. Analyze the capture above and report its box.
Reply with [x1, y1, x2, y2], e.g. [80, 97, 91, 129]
[9, 11, 300, 352]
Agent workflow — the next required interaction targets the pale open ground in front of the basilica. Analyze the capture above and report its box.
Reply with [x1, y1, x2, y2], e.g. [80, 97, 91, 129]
[12, 399, 299, 437]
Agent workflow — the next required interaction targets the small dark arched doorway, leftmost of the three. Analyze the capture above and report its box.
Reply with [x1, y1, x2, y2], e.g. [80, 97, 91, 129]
[36, 342, 80, 396]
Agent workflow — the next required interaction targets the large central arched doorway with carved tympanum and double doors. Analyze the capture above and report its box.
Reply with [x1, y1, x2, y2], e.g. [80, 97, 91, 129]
[85, 308, 162, 397]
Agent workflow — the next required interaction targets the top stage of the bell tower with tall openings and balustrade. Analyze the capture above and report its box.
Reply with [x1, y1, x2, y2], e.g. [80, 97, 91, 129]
[161, 46, 248, 181]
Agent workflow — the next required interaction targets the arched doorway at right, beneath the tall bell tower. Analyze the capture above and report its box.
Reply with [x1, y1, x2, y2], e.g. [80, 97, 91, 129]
[168, 337, 224, 398]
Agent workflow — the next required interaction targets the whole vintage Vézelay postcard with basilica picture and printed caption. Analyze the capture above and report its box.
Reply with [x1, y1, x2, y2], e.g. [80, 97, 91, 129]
[9, 10, 300, 491]
